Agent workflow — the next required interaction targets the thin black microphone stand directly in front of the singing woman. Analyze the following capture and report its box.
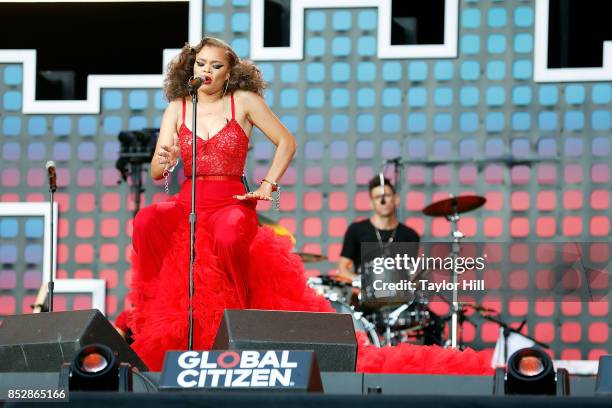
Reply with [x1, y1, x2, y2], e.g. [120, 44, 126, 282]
[187, 89, 198, 350]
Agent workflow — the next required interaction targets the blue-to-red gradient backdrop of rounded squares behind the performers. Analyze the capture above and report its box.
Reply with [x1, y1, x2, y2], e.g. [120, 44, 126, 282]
[0, 0, 612, 359]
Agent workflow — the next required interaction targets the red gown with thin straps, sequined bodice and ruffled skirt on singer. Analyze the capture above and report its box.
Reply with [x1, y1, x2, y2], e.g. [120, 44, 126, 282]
[127, 95, 333, 370]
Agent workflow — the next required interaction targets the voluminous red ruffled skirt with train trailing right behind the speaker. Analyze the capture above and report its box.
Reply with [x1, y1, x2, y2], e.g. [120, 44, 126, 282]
[123, 178, 492, 374]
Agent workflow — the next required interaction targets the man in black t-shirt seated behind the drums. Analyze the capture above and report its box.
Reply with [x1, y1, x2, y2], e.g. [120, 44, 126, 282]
[338, 177, 419, 280]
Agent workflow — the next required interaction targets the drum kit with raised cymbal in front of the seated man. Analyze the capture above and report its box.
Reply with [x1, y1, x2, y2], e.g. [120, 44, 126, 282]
[262, 195, 486, 348]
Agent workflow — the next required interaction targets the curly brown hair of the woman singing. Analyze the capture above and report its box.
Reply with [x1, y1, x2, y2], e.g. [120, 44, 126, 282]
[164, 37, 266, 101]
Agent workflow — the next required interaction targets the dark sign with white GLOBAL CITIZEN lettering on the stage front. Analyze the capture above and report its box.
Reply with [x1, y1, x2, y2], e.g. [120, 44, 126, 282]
[160, 350, 321, 390]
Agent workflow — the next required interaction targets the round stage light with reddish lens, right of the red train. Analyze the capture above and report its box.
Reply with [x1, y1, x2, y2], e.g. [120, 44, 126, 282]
[494, 347, 569, 395]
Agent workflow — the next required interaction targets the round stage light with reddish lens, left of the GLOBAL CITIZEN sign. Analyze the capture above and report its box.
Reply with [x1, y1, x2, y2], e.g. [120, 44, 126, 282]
[60, 344, 132, 392]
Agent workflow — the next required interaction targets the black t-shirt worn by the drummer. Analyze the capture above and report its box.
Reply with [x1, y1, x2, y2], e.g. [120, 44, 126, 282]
[340, 219, 419, 272]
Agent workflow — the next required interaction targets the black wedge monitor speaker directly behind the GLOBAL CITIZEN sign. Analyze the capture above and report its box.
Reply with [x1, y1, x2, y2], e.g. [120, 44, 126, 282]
[213, 310, 357, 371]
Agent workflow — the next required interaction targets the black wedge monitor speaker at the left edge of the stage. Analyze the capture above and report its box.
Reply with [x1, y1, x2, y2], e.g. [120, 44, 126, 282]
[0, 309, 148, 372]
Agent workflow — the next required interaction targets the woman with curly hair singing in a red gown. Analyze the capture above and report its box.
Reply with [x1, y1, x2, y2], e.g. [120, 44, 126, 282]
[123, 37, 332, 370]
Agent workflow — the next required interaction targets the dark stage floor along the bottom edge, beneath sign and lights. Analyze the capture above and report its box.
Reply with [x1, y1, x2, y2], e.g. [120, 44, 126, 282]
[0, 372, 612, 408]
